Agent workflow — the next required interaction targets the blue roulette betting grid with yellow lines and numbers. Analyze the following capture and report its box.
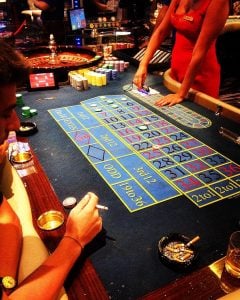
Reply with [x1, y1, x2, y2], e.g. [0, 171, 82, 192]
[49, 95, 240, 212]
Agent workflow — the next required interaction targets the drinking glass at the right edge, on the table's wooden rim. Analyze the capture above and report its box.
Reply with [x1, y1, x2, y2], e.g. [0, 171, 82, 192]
[225, 231, 240, 278]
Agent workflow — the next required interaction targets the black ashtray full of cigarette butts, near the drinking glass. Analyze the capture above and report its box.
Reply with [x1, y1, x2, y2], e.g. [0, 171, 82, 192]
[158, 233, 199, 270]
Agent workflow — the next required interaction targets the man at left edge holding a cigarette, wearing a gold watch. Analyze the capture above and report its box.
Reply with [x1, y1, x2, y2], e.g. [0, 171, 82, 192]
[0, 41, 102, 300]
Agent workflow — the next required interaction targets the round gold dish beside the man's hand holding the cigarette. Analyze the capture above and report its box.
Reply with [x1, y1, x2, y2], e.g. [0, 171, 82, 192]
[37, 210, 64, 230]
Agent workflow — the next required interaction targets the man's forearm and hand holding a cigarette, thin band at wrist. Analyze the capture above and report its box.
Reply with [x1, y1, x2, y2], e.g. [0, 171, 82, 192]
[6, 193, 102, 300]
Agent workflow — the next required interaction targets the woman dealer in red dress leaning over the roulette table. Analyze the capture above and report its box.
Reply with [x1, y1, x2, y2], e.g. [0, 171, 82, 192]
[133, 0, 229, 106]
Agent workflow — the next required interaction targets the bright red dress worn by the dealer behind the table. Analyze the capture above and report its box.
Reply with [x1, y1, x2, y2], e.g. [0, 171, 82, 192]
[171, 0, 220, 98]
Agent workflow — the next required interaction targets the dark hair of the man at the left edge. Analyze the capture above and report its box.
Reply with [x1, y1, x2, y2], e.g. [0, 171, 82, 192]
[0, 39, 30, 86]
